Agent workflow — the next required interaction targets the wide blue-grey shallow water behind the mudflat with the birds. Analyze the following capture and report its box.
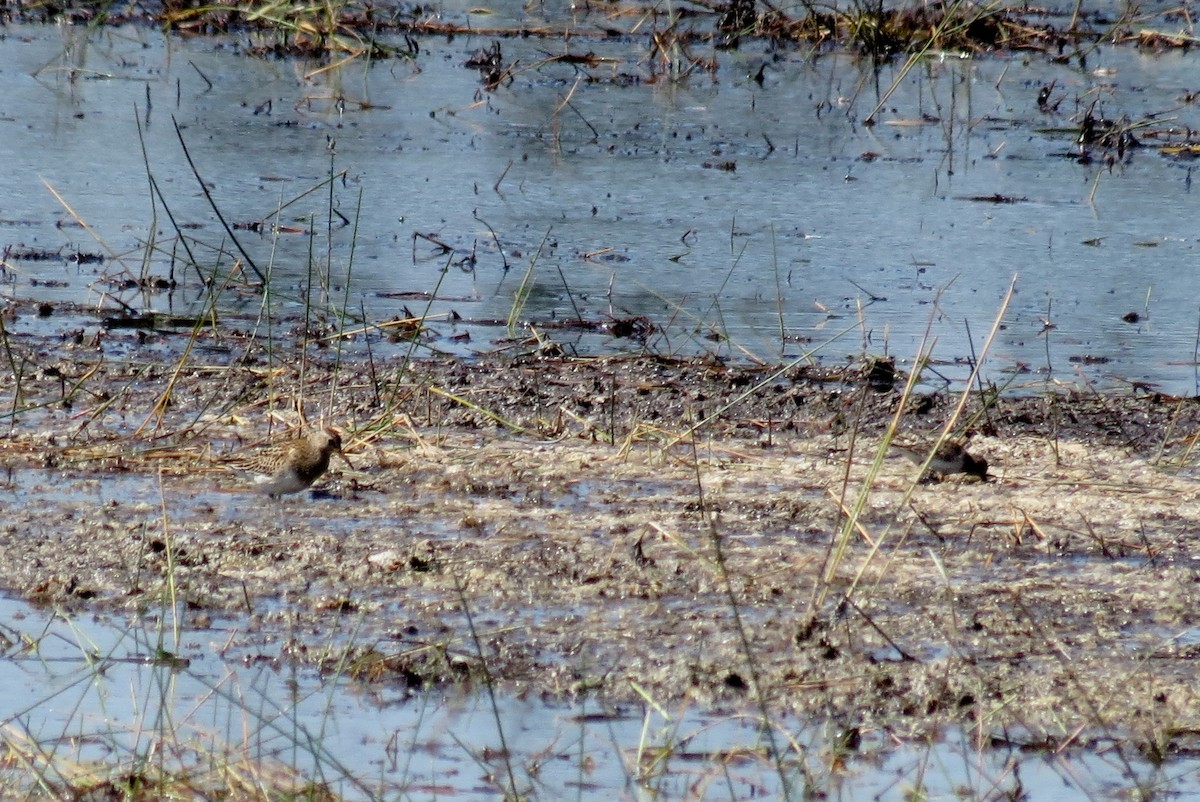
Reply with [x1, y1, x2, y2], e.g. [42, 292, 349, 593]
[0, 14, 1200, 393]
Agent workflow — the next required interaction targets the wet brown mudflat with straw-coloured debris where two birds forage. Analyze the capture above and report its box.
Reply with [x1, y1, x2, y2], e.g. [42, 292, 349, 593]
[0, 359, 1200, 749]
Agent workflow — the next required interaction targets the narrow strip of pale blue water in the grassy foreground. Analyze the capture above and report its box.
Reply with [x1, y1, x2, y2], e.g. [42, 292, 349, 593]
[0, 600, 1200, 801]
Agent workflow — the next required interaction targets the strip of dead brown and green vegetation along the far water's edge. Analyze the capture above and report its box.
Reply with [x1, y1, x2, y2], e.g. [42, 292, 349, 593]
[8, 0, 1196, 65]
